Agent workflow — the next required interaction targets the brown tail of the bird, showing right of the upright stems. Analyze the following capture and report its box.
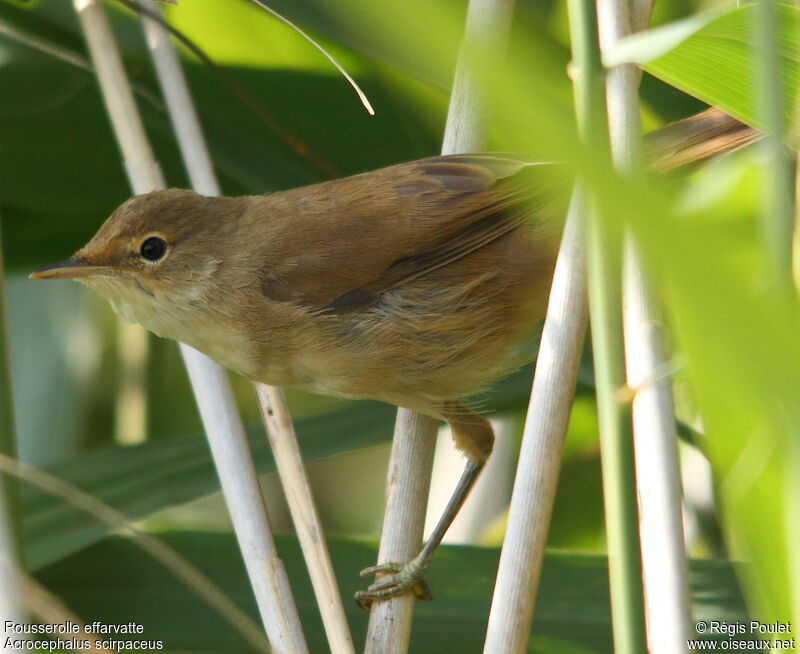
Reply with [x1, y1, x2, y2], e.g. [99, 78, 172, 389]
[645, 108, 761, 172]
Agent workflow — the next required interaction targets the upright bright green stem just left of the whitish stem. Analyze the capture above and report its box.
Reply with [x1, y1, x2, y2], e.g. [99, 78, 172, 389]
[568, 0, 646, 654]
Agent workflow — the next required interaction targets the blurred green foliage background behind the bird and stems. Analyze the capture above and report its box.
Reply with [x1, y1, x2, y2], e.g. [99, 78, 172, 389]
[0, 0, 800, 652]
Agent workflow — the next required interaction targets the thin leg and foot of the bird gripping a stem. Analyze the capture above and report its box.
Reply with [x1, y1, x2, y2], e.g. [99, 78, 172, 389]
[356, 401, 494, 609]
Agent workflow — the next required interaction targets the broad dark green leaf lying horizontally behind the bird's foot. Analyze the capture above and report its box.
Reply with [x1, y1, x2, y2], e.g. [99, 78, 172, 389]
[32, 532, 747, 654]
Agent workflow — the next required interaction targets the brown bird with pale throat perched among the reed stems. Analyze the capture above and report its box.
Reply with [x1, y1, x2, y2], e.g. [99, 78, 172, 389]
[31, 110, 755, 606]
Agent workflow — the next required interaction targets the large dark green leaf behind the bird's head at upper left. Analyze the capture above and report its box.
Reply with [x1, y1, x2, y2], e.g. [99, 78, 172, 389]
[0, 0, 446, 269]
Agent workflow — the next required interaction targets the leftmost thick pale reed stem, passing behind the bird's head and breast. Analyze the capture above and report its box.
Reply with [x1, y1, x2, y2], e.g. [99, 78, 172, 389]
[74, 0, 308, 654]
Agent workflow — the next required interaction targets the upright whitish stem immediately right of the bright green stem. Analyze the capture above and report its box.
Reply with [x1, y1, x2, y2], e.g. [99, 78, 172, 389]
[598, 0, 691, 654]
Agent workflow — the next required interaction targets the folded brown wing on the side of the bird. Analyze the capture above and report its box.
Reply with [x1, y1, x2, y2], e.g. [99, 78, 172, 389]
[261, 154, 564, 314]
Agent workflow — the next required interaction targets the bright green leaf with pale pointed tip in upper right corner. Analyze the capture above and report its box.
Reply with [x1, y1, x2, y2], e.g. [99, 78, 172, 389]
[604, 3, 800, 125]
